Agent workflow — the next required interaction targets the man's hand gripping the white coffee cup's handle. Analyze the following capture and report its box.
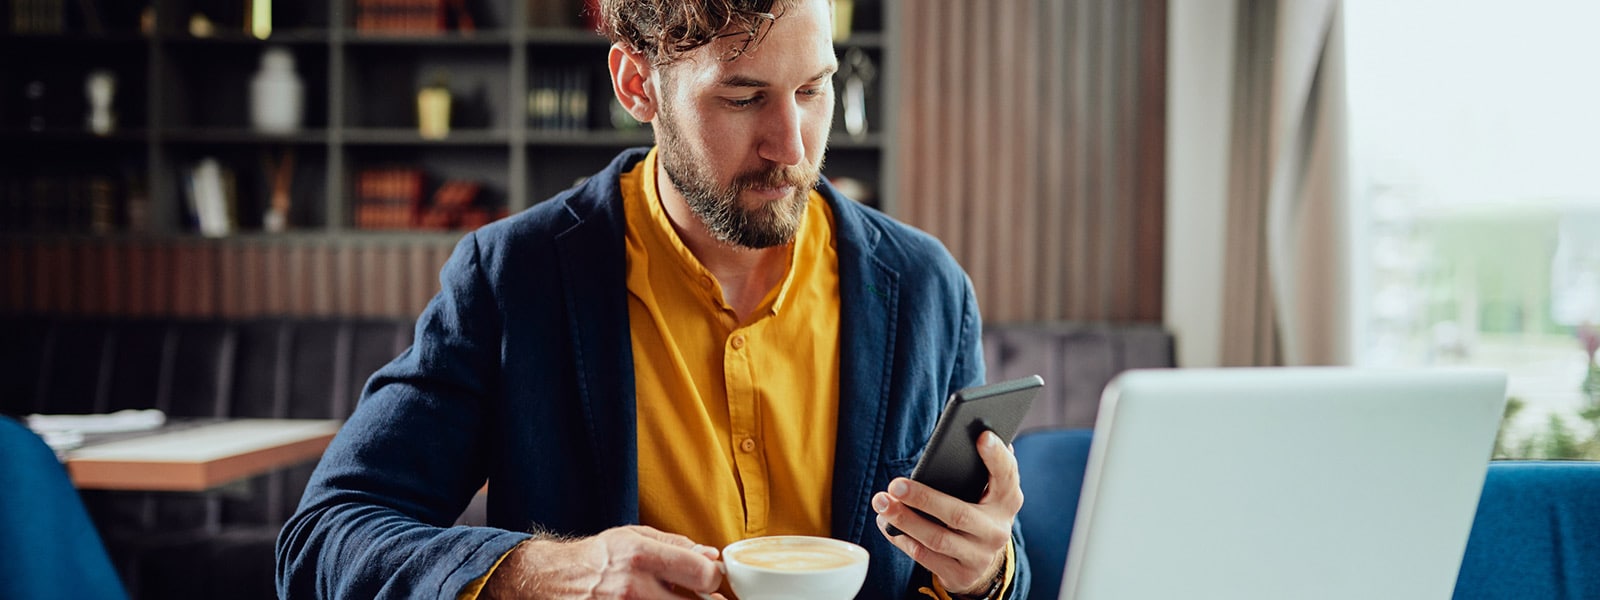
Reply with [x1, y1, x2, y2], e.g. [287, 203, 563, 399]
[480, 525, 722, 598]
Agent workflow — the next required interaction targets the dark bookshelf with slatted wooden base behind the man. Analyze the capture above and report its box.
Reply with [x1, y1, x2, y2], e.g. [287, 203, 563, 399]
[0, 0, 896, 318]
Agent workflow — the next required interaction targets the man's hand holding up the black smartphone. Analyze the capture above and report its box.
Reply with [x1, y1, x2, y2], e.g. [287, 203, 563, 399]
[872, 432, 1022, 594]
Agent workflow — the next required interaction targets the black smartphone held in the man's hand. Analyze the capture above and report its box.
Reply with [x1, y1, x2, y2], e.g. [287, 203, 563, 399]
[888, 374, 1045, 536]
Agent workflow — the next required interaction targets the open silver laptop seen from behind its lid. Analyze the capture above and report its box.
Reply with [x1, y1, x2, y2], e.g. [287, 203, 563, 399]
[1061, 368, 1506, 600]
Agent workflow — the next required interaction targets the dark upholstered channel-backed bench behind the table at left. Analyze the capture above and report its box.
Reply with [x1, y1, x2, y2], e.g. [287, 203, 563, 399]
[0, 317, 411, 598]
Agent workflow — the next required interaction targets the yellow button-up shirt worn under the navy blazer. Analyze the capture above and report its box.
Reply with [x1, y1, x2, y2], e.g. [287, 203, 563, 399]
[621, 152, 838, 547]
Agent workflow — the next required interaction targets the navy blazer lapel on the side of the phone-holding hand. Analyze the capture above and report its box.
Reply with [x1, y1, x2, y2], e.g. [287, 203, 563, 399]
[822, 192, 899, 541]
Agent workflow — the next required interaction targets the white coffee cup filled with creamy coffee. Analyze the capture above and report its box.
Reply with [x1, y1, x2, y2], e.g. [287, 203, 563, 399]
[722, 536, 869, 600]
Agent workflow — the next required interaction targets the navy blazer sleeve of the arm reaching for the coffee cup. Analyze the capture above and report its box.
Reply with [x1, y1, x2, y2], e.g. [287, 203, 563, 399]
[277, 234, 528, 598]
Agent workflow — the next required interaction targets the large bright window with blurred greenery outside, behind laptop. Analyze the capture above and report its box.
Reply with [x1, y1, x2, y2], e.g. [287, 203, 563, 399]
[1344, 0, 1600, 459]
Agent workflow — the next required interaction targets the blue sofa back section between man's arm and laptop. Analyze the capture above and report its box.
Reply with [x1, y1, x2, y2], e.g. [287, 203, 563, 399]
[1013, 429, 1094, 600]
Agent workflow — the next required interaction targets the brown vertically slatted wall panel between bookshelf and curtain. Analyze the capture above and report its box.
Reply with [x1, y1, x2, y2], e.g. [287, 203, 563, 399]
[888, 0, 1166, 323]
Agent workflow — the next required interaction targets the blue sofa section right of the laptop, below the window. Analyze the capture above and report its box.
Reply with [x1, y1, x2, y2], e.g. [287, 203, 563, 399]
[1454, 461, 1600, 600]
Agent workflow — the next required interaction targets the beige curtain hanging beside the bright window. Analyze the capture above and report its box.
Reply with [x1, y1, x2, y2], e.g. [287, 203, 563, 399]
[1221, 0, 1350, 366]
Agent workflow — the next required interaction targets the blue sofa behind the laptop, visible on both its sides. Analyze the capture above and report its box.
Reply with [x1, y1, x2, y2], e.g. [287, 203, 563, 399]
[1014, 429, 1600, 600]
